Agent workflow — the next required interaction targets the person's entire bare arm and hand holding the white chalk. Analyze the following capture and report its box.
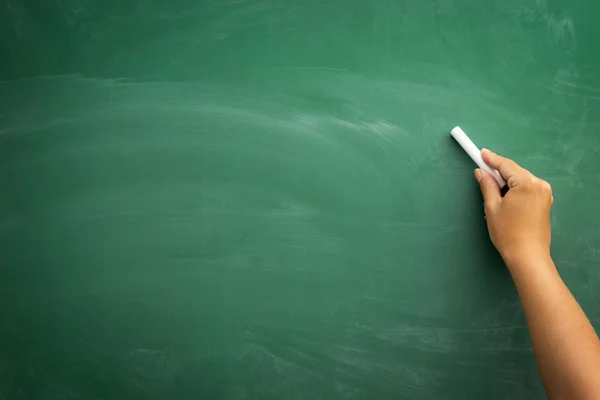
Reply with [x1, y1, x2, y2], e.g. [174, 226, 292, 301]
[475, 150, 600, 400]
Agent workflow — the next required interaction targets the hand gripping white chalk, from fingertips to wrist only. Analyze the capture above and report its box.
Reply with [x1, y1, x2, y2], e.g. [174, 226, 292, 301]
[475, 150, 554, 268]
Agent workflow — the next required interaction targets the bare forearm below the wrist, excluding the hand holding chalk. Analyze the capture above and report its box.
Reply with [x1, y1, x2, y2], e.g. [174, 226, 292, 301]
[507, 255, 600, 399]
